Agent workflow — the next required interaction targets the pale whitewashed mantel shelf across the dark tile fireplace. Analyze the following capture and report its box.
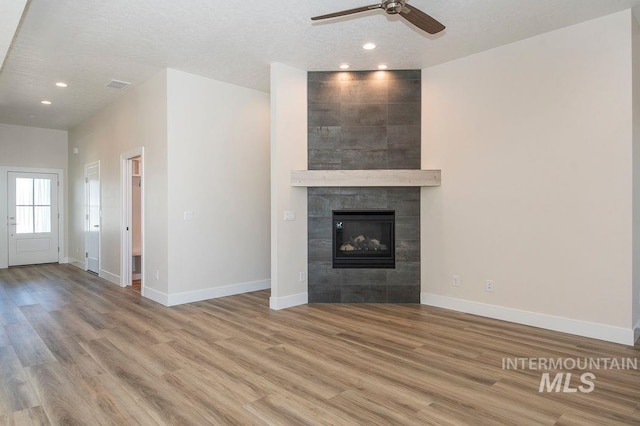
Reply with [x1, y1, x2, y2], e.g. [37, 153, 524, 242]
[291, 170, 440, 187]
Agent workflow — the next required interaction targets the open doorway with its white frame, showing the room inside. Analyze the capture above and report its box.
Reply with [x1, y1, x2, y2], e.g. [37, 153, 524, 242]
[121, 149, 144, 293]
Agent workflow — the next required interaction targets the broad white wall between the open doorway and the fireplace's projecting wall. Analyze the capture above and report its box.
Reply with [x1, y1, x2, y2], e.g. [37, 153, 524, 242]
[167, 70, 270, 305]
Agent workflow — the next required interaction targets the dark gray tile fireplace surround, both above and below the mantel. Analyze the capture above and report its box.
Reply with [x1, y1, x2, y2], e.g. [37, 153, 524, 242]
[308, 70, 421, 303]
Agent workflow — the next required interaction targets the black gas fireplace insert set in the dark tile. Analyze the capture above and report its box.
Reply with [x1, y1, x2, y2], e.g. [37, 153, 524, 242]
[333, 210, 396, 269]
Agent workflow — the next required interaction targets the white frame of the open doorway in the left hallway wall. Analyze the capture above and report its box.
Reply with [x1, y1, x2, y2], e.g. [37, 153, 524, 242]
[120, 147, 146, 296]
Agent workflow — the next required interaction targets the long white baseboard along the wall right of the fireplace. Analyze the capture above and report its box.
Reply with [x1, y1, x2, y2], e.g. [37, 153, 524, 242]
[420, 293, 635, 346]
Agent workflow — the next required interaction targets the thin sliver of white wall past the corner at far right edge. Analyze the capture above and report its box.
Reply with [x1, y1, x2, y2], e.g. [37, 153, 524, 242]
[631, 10, 640, 339]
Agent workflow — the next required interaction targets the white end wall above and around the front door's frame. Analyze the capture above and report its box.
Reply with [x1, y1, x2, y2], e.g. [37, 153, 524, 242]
[0, 124, 68, 268]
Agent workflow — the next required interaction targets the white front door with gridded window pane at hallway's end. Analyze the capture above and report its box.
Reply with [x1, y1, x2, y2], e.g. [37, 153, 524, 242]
[7, 172, 58, 266]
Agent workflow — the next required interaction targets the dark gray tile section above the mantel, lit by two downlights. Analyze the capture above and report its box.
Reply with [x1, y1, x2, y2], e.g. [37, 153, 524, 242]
[308, 70, 421, 170]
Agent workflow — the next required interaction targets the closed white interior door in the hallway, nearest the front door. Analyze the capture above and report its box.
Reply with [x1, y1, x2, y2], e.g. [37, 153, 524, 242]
[85, 163, 100, 274]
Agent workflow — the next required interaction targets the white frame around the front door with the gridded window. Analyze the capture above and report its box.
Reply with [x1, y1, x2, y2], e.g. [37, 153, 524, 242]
[0, 166, 64, 269]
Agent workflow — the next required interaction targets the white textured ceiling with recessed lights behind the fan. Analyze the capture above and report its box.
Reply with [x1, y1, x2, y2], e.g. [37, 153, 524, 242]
[0, 0, 640, 129]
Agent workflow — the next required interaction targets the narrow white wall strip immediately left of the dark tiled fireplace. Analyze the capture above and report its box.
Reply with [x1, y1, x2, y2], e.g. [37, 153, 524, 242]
[270, 63, 308, 309]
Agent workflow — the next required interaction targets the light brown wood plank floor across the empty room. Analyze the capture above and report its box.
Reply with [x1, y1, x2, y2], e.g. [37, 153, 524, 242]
[0, 265, 640, 425]
